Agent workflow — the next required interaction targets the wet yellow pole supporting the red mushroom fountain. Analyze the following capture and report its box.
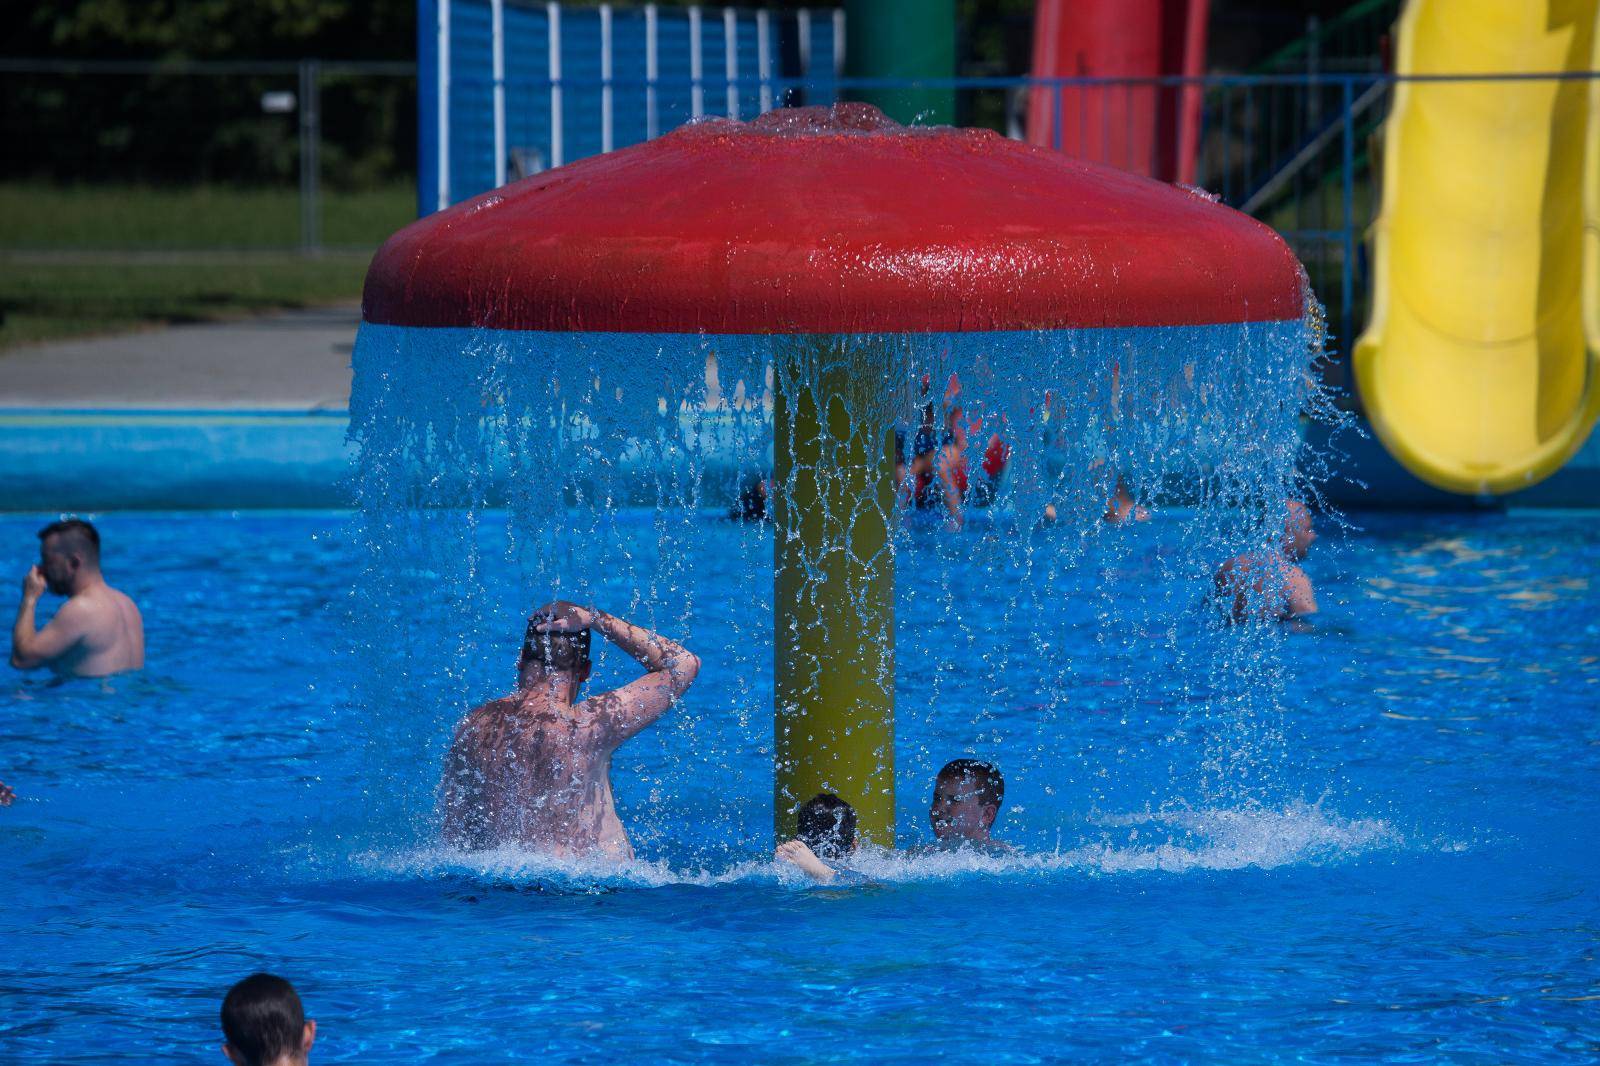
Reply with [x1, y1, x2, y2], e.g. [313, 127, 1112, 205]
[773, 336, 894, 847]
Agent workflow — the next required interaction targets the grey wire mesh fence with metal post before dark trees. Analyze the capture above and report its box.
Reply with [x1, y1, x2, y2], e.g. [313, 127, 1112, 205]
[0, 59, 416, 253]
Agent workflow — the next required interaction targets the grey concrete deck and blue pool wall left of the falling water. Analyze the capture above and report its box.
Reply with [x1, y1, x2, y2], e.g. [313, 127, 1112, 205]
[0, 304, 360, 512]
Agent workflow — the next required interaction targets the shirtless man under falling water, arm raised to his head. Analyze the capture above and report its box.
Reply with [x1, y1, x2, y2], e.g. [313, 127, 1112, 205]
[443, 600, 699, 861]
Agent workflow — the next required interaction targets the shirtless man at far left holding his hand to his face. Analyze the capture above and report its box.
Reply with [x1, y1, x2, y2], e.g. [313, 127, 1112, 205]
[11, 519, 144, 677]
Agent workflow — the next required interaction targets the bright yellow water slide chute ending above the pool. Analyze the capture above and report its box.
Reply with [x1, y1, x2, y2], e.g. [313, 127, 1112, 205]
[1355, 0, 1600, 495]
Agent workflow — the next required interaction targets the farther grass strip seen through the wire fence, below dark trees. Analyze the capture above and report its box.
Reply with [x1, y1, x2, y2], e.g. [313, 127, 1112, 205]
[0, 182, 416, 251]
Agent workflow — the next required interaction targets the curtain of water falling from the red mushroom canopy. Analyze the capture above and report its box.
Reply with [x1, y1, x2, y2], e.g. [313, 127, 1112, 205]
[352, 302, 1326, 855]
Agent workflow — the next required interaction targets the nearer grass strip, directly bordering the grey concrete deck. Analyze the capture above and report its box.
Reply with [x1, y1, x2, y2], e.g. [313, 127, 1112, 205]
[0, 253, 370, 347]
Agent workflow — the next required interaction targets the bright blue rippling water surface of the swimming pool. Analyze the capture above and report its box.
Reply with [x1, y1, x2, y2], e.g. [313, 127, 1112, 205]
[0, 512, 1600, 1063]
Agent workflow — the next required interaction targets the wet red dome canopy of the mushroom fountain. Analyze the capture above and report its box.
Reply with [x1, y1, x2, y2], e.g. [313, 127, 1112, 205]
[363, 104, 1304, 333]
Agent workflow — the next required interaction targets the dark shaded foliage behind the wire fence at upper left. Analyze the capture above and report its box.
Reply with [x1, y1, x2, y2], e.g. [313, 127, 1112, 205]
[0, 0, 416, 187]
